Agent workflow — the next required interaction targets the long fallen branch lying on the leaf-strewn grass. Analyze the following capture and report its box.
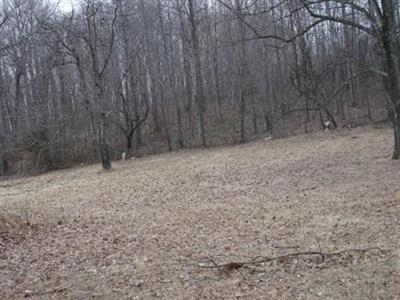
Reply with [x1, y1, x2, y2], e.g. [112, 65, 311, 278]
[198, 247, 387, 270]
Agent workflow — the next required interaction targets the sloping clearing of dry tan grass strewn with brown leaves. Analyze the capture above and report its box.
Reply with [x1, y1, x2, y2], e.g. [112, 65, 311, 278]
[0, 128, 400, 299]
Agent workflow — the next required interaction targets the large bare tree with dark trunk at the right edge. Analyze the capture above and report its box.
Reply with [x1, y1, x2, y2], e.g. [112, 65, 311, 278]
[301, 0, 400, 159]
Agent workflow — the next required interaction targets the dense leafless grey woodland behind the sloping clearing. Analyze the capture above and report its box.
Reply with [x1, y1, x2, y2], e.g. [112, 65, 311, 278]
[0, 0, 400, 175]
